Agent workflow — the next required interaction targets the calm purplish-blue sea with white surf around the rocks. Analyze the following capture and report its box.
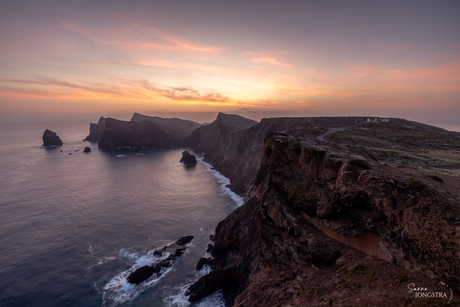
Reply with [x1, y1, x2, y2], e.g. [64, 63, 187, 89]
[0, 123, 241, 307]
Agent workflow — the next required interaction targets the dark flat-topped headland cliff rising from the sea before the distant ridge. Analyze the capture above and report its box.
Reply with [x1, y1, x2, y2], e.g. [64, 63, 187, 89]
[98, 118, 179, 149]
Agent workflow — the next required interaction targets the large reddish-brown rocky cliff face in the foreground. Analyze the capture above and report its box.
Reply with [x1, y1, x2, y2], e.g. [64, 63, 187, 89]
[189, 133, 460, 306]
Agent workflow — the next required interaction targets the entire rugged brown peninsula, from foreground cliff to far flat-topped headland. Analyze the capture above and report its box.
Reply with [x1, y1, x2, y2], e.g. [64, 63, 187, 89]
[83, 113, 460, 306]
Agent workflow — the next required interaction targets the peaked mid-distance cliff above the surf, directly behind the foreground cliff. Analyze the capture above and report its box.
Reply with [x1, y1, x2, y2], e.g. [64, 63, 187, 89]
[184, 113, 363, 194]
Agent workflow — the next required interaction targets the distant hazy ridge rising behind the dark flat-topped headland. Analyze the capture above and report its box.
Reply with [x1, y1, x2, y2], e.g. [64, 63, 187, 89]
[130, 113, 201, 139]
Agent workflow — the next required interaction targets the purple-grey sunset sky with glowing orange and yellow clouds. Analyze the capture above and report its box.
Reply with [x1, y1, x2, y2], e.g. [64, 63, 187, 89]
[0, 0, 460, 126]
